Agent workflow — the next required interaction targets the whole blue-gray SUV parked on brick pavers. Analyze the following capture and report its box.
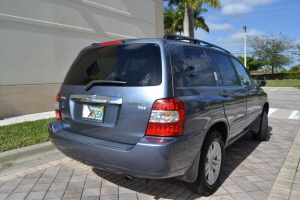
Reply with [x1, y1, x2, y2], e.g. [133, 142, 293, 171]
[49, 34, 269, 195]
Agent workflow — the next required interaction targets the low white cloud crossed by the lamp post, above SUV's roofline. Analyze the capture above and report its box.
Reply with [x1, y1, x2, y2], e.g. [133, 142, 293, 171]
[216, 29, 265, 48]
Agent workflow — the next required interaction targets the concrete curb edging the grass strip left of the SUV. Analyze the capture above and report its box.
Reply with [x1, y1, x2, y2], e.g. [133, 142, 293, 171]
[0, 142, 58, 165]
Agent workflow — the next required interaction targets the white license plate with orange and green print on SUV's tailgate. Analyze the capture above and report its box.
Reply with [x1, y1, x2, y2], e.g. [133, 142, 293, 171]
[82, 104, 104, 122]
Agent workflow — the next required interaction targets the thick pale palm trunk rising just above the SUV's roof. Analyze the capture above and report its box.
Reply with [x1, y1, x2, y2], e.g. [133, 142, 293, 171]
[183, 3, 194, 37]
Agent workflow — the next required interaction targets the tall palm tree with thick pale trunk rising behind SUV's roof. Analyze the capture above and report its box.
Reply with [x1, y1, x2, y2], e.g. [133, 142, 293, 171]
[164, 0, 221, 37]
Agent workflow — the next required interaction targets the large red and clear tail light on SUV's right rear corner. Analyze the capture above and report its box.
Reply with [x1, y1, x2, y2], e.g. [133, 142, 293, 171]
[146, 98, 185, 137]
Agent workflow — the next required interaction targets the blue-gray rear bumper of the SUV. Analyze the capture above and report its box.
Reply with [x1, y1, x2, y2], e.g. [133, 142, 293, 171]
[48, 121, 203, 179]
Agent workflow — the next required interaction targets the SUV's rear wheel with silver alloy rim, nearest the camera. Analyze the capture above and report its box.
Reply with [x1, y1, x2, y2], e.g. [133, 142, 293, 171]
[186, 131, 225, 196]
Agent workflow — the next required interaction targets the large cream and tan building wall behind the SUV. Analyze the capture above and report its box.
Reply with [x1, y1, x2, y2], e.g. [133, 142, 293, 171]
[0, 0, 163, 118]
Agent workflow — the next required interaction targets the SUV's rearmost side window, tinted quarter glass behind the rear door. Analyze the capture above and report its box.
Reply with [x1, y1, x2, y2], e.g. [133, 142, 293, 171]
[184, 48, 215, 85]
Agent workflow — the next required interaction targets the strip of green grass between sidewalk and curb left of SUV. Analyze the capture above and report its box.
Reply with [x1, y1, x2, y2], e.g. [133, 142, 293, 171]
[0, 118, 55, 152]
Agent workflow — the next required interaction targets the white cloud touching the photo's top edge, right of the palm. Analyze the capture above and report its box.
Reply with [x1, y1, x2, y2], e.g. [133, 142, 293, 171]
[220, 0, 279, 15]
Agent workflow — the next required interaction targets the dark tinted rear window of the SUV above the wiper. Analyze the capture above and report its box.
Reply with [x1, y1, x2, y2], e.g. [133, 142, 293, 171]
[64, 44, 162, 86]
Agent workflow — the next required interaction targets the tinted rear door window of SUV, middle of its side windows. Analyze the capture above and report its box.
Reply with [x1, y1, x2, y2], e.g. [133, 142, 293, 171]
[211, 53, 239, 85]
